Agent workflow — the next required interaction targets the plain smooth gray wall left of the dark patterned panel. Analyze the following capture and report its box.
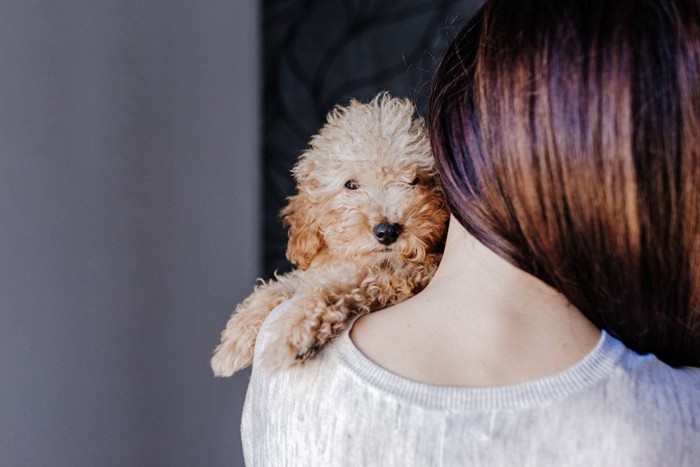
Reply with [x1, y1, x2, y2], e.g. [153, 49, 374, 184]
[0, 0, 260, 467]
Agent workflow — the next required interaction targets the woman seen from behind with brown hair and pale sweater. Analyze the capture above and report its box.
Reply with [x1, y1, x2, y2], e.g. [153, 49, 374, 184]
[242, 0, 700, 466]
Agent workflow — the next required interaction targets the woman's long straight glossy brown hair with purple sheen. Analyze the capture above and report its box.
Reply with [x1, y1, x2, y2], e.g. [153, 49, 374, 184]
[428, 0, 700, 366]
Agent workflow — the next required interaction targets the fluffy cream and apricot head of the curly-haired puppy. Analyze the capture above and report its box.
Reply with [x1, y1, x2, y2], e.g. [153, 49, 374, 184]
[282, 93, 448, 269]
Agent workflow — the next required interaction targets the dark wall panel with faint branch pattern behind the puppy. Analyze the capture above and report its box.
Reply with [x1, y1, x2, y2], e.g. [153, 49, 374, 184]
[263, 0, 480, 275]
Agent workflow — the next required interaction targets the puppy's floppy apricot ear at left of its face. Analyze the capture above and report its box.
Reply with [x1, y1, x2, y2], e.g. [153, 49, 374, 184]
[281, 194, 323, 270]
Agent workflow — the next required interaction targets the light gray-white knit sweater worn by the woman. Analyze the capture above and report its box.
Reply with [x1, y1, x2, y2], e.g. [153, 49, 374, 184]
[241, 304, 700, 467]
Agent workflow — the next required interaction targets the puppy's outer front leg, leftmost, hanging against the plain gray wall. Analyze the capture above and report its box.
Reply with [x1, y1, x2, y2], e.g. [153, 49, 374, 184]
[211, 272, 298, 376]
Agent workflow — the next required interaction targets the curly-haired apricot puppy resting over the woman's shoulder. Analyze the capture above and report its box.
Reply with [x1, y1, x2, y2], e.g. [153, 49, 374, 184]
[211, 93, 448, 376]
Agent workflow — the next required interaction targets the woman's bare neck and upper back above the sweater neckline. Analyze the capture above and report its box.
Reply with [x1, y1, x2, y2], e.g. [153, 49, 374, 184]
[351, 218, 600, 386]
